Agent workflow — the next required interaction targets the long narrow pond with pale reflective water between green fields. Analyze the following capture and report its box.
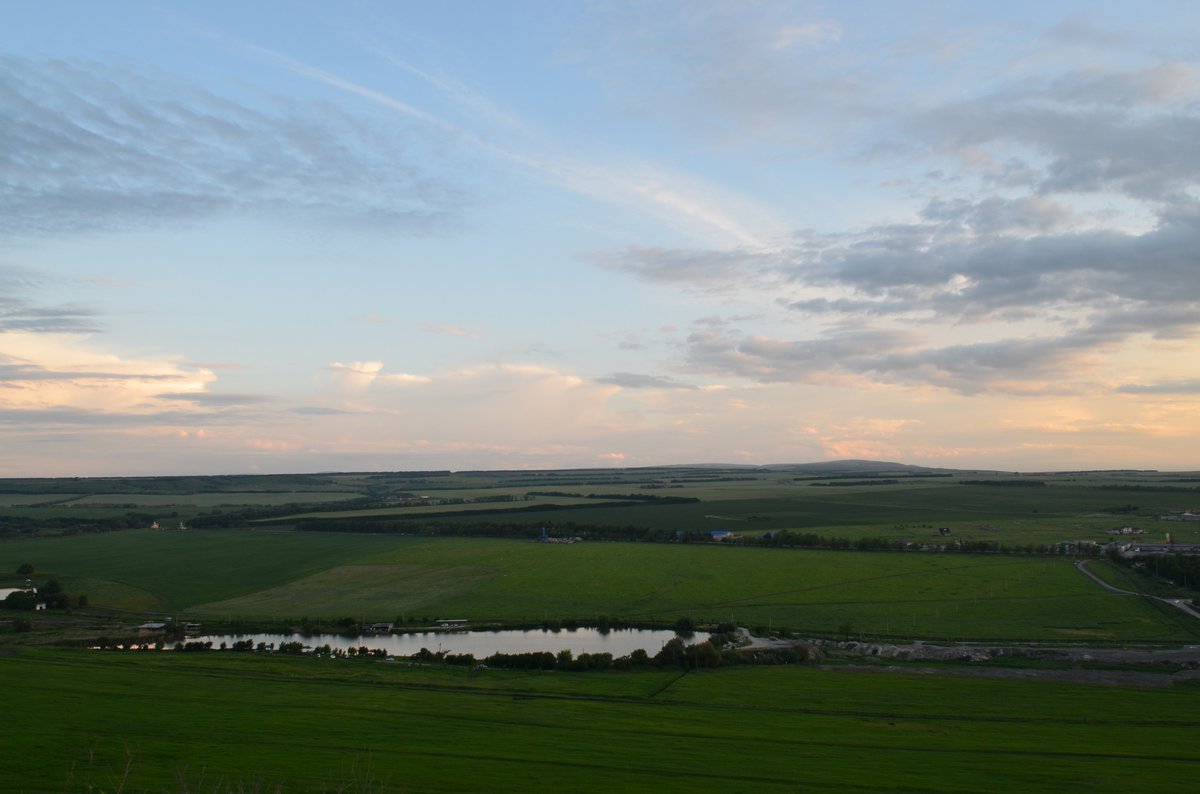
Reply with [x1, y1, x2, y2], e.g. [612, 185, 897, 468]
[187, 628, 708, 658]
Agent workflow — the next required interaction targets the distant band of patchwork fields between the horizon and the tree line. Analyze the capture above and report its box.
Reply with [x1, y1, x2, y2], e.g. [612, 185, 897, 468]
[9, 462, 1200, 547]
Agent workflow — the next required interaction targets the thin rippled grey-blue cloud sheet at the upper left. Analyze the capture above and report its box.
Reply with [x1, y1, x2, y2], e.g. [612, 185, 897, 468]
[0, 55, 466, 235]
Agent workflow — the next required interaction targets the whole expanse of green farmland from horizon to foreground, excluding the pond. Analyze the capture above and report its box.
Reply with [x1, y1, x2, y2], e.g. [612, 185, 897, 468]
[0, 463, 1200, 794]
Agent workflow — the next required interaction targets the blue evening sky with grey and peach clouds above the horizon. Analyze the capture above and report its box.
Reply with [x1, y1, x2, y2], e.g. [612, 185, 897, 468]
[0, 0, 1200, 477]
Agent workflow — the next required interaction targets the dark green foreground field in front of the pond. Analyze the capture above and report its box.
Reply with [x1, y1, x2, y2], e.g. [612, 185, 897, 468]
[0, 649, 1200, 793]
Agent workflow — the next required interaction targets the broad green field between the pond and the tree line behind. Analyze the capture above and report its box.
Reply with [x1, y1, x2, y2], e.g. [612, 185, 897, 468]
[0, 530, 1200, 643]
